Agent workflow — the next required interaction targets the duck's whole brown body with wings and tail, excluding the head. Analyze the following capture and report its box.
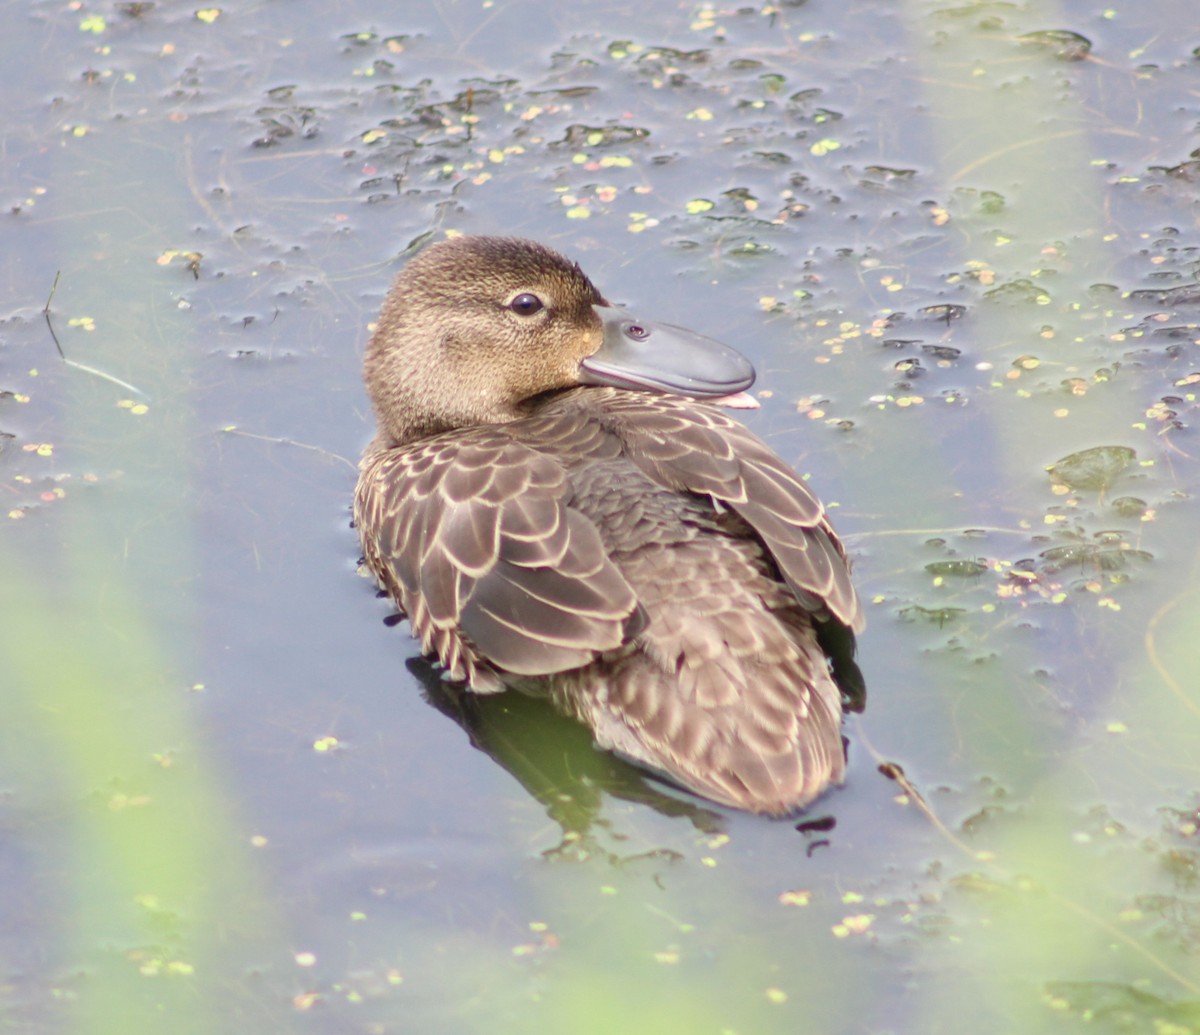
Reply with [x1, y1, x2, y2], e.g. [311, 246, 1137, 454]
[356, 389, 858, 813]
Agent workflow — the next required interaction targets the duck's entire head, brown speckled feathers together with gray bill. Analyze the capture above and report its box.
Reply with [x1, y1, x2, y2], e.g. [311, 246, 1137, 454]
[364, 237, 754, 444]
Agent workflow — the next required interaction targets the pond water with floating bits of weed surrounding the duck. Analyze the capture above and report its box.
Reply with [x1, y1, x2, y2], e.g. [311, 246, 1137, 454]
[0, 0, 1200, 1035]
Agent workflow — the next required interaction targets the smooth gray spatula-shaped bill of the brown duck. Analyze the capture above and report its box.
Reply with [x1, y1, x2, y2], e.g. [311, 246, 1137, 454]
[580, 305, 754, 399]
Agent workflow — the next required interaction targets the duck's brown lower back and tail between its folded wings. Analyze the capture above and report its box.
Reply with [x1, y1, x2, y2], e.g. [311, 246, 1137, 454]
[550, 451, 844, 813]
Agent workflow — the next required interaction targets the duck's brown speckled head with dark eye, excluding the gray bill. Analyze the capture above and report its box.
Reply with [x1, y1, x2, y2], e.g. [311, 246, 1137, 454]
[364, 237, 605, 445]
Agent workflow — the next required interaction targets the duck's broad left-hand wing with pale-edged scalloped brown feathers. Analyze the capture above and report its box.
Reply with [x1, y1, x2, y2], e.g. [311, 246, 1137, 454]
[354, 429, 644, 690]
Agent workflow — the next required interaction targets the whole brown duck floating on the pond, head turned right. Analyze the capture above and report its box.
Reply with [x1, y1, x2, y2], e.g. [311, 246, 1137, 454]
[354, 235, 864, 816]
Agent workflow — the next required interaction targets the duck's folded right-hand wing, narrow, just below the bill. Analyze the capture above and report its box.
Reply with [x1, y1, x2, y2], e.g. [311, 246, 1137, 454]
[592, 391, 864, 632]
